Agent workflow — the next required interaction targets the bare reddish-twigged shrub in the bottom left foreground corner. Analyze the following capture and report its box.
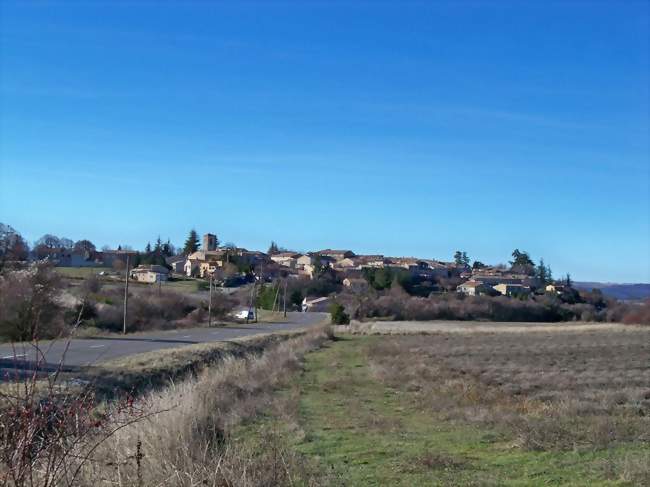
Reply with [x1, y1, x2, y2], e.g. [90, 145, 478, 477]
[0, 332, 148, 487]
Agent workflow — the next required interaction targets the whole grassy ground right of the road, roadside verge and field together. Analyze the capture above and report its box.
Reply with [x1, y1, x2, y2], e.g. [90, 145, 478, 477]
[11, 316, 650, 487]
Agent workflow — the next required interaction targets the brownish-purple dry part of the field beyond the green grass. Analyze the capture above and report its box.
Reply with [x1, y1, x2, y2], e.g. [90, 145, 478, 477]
[369, 328, 650, 450]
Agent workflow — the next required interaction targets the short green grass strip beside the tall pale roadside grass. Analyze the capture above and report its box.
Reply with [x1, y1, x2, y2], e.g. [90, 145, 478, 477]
[235, 336, 650, 486]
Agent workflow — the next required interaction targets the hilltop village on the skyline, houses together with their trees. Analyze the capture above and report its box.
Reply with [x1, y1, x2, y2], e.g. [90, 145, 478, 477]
[1, 227, 571, 309]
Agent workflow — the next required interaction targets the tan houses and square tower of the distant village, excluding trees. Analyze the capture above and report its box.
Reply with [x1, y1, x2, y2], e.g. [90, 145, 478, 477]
[39, 233, 562, 298]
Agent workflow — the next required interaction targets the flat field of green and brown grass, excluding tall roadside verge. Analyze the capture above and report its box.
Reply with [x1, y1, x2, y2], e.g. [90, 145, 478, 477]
[234, 329, 650, 486]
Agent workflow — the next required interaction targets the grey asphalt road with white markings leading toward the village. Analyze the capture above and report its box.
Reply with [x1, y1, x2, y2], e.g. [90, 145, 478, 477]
[0, 312, 326, 380]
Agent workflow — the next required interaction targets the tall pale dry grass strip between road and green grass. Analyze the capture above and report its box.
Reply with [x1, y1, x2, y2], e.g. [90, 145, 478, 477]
[74, 329, 330, 486]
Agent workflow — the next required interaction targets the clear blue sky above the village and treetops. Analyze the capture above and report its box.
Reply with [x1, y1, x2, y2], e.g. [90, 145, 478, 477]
[0, 1, 650, 282]
